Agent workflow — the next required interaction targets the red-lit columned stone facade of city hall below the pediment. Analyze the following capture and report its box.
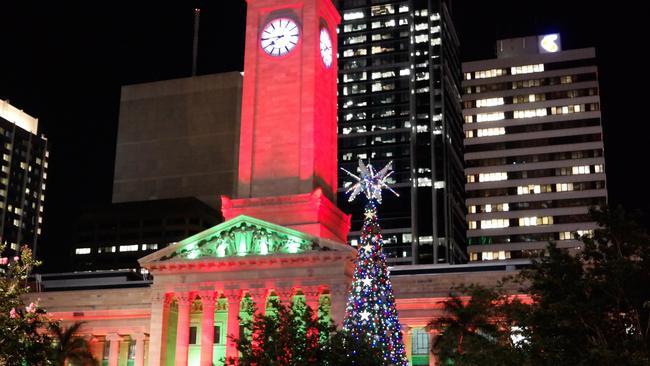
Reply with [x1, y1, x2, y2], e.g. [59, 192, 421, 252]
[25, 258, 517, 366]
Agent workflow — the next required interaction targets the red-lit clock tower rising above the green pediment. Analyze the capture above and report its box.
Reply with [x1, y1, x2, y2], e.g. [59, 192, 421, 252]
[222, 0, 350, 242]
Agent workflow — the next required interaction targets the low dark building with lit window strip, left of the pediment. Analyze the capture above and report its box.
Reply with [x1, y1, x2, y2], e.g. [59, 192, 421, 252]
[70, 197, 222, 271]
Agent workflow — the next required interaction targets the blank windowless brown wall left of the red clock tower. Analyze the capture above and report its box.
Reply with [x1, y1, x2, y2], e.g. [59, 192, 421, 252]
[113, 72, 242, 209]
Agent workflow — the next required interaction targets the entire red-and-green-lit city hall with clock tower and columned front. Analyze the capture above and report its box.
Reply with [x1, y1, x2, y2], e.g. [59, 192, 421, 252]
[26, 0, 523, 366]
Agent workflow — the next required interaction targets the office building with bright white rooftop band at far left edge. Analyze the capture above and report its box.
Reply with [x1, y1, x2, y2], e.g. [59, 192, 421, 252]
[0, 100, 49, 253]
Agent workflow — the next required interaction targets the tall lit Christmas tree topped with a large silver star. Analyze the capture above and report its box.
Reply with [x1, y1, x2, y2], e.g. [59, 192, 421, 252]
[343, 161, 408, 366]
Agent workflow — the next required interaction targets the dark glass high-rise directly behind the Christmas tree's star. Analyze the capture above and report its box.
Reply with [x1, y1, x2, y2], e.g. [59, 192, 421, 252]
[338, 0, 466, 264]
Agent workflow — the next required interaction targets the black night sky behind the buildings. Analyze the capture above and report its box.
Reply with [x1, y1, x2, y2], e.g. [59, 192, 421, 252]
[0, 0, 650, 271]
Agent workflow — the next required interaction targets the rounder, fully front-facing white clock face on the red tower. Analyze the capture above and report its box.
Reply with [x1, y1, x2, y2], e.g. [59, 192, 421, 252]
[260, 18, 300, 56]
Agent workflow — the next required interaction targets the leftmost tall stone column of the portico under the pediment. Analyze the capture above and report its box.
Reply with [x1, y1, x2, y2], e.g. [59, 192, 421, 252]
[149, 292, 172, 365]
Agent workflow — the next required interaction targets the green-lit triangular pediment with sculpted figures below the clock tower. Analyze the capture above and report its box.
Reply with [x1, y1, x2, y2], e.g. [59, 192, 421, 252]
[138, 215, 354, 267]
